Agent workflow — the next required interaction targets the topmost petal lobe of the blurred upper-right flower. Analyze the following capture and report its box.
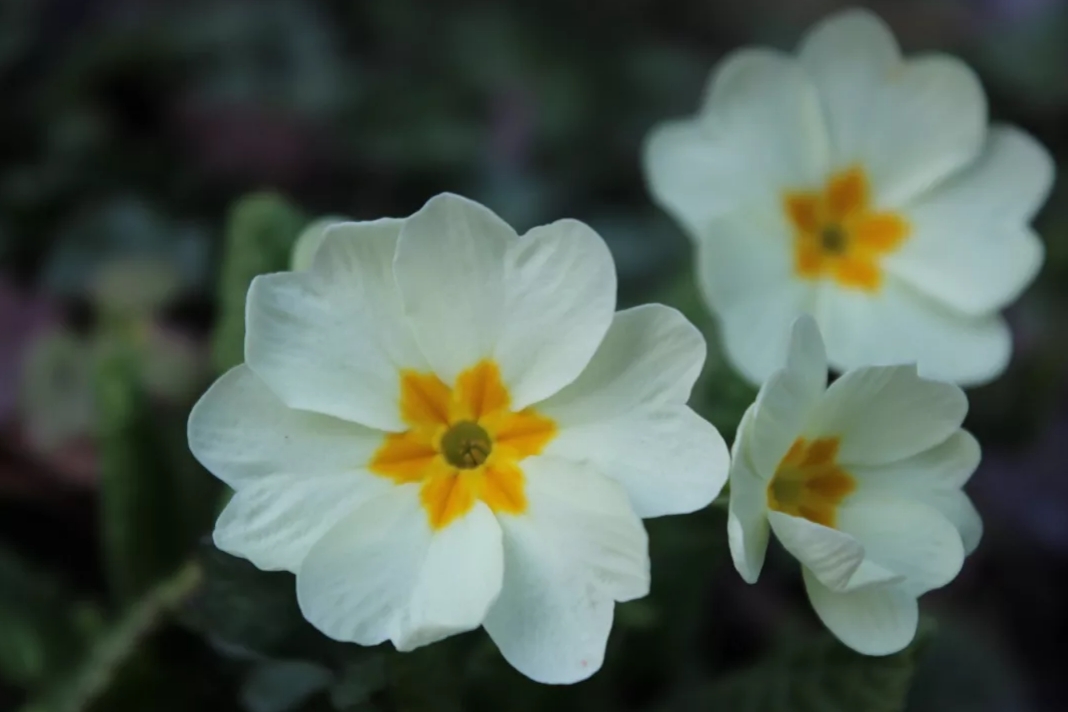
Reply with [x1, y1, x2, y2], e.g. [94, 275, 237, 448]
[799, 9, 901, 165]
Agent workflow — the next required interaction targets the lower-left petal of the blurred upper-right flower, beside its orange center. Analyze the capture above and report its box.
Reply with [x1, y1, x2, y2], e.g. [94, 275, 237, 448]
[697, 209, 817, 385]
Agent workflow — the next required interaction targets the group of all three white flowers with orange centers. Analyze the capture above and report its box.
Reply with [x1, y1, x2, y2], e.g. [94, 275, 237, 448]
[189, 12, 1052, 683]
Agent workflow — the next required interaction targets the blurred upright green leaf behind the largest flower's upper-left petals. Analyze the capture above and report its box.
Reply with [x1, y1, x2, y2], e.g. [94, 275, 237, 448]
[213, 193, 307, 371]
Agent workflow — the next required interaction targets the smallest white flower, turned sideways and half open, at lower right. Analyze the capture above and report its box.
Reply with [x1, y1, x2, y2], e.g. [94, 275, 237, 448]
[727, 316, 983, 655]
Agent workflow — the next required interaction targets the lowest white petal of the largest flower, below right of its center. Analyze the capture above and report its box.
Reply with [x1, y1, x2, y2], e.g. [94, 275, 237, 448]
[485, 457, 649, 684]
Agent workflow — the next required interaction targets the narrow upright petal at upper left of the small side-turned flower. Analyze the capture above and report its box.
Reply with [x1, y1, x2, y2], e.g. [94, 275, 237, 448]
[748, 316, 827, 481]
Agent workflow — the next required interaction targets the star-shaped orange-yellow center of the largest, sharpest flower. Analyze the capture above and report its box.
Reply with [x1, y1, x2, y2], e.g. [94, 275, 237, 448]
[370, 360, 556, 529]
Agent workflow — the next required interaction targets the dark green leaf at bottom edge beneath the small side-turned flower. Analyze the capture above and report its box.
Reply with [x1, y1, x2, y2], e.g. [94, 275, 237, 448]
[664, 630, 928, 712]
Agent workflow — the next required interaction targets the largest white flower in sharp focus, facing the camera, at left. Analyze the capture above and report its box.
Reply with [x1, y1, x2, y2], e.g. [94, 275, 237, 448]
[189, 194, 728, 683]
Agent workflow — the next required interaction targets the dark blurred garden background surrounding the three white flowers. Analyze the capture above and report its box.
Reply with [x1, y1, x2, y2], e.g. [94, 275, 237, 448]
[0, 0, 1068, 712]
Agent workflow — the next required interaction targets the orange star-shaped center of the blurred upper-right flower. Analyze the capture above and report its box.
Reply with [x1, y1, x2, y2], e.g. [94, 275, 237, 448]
[783, 168, 909, 291]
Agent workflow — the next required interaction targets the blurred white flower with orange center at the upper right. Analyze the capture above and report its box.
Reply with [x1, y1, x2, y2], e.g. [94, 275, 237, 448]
[645, 6, 1053, 383]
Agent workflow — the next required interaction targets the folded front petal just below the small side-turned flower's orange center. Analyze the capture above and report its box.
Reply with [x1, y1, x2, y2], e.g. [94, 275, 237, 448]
[768, 511, 900, 591]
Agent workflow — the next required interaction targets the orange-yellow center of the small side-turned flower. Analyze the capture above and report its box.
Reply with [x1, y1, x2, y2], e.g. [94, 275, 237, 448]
[768, 438, 857, 527]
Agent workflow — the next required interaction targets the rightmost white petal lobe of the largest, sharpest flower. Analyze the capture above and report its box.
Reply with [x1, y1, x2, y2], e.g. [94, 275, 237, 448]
[546, 406, 731, 519]
